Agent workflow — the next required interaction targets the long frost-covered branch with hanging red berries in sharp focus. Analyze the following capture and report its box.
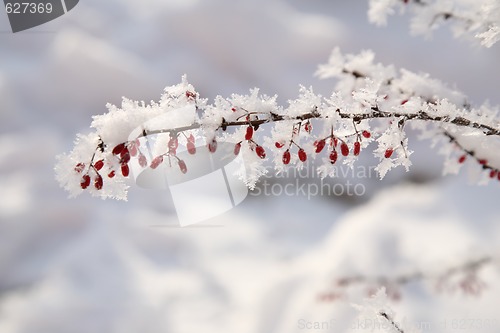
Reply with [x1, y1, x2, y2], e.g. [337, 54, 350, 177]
[56, 49, 500, 199]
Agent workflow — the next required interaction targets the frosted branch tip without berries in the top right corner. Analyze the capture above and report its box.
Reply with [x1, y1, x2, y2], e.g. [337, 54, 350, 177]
[368, 0, 500, 47]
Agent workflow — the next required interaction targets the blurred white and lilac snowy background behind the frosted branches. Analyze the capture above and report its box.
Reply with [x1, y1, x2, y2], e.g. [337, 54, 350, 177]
[0, 0, 500, 333]
